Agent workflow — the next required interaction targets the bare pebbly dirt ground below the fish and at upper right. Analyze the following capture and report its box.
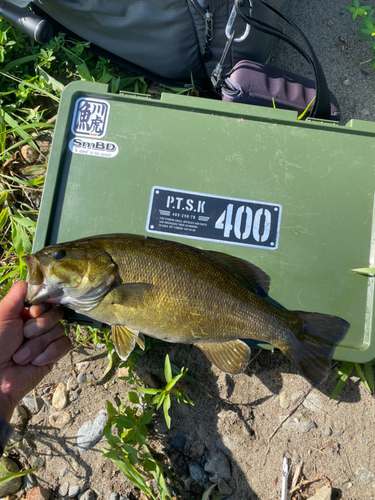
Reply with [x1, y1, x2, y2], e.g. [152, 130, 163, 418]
[6, 0, 375, 500]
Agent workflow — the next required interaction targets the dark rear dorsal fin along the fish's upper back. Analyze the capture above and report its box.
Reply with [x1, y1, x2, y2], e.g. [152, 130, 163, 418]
[208, 251, 271, 296]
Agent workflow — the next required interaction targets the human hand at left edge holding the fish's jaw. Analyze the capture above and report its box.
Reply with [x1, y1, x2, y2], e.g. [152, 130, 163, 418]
[0, 282, 71, 422]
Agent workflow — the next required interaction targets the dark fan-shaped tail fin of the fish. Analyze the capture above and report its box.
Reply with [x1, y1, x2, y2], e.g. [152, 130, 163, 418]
[282, 311, 350, 384]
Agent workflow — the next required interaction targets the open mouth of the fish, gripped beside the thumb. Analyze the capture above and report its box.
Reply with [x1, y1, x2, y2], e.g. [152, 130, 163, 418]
[22, 255, 63, 306]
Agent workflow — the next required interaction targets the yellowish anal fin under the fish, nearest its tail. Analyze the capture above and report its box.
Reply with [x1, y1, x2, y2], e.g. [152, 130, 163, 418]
[194, 340, 251, 375]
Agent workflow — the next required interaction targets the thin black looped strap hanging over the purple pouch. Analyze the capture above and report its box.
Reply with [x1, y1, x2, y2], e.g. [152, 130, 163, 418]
[234, 0, 331, 120]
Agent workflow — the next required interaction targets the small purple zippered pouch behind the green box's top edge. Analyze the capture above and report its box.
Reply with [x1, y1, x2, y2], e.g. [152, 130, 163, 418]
[221, 61, 340, 121]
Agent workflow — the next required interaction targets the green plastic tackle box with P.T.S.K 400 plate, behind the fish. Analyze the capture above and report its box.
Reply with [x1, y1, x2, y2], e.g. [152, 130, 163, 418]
[33, 82, 375, 363]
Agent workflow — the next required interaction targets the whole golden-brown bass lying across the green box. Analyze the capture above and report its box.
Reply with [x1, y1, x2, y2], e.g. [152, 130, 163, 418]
[23, 234, 350, 384]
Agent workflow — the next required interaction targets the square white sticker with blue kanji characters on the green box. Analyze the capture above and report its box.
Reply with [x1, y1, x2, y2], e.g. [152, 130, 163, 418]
[71, 97, 110, 138]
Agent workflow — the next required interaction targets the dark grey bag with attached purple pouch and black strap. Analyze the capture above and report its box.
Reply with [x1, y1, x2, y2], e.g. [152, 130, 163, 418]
[4, 0, 340, 120]
